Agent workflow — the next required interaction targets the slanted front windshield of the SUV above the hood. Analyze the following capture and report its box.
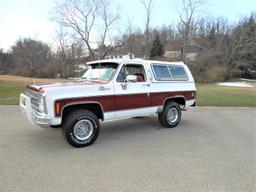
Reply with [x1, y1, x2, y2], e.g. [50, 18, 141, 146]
[81, 63, 118, 81]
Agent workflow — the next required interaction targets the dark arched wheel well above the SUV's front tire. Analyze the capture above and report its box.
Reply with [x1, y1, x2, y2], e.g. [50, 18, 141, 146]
[62, 103, 104, 121]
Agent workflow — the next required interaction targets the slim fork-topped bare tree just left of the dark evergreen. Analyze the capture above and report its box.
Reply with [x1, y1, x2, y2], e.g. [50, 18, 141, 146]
[141, 0, 153, 58]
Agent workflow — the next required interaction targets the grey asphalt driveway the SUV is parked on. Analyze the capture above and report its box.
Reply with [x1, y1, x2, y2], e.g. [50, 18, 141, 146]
[0, 106, 256, 192]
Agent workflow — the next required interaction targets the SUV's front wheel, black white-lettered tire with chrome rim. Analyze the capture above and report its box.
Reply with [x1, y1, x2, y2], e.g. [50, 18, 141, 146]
[62, 110, 100, 147]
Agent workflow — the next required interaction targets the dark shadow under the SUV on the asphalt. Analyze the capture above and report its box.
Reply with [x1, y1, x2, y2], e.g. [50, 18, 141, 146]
[30, 116, 195, 151]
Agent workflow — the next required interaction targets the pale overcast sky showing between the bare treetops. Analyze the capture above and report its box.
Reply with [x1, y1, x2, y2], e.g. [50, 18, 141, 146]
[0, 0, 256, 50]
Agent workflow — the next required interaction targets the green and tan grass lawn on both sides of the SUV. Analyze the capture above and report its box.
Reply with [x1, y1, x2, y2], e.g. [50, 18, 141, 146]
[0, 75, 256, 107]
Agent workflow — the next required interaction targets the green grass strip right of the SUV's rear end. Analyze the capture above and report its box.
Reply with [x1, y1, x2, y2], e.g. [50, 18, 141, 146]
[196, 84, 256, 107]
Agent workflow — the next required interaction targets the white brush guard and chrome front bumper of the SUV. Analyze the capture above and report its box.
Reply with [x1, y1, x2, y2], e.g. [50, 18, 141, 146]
[19, 93, 50, 127]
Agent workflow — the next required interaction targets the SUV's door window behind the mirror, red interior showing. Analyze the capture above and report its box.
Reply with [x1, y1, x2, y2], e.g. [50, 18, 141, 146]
[116, 64, 146, 82]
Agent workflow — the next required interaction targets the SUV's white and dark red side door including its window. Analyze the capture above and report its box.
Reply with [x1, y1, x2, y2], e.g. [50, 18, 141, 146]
[115, 64, 151, 118]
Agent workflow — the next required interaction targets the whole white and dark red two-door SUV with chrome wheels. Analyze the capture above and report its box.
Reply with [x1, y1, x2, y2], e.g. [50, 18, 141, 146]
[20, 59, 196, 147]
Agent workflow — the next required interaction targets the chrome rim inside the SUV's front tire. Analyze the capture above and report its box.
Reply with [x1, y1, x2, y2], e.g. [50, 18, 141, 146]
[73, 119, 93, 140]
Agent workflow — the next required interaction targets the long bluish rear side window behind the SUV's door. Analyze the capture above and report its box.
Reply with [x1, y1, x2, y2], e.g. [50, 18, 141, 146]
[152, 65, 188, 81]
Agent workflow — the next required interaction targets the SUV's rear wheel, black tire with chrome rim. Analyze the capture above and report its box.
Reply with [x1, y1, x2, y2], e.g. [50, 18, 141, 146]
[158, 101, 181, 128]
